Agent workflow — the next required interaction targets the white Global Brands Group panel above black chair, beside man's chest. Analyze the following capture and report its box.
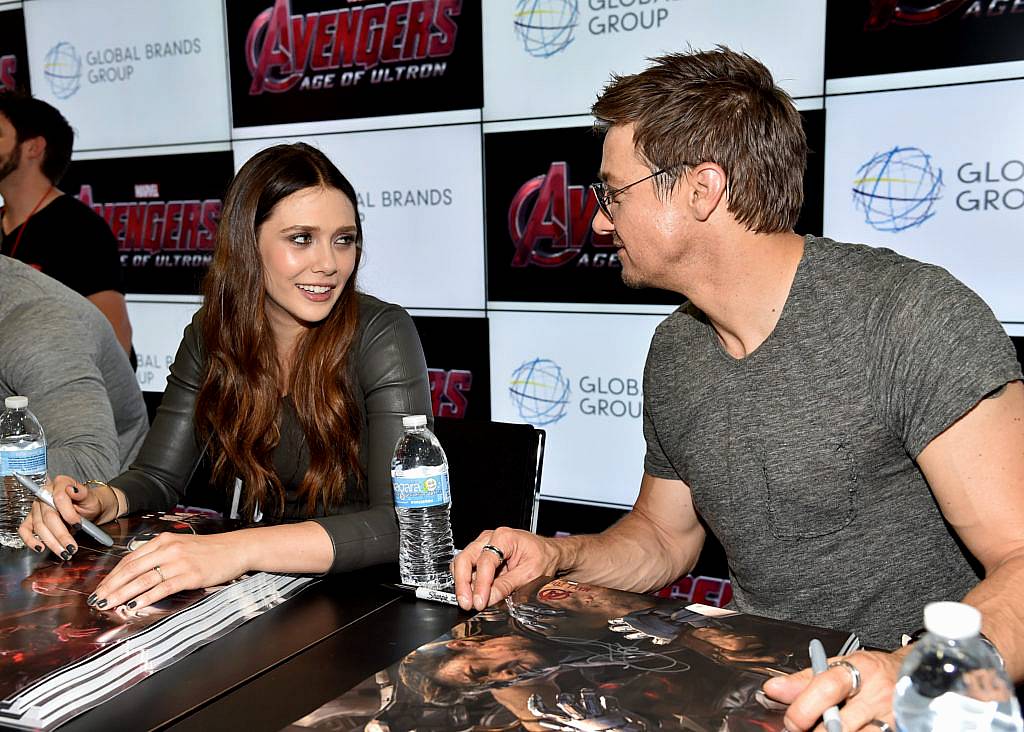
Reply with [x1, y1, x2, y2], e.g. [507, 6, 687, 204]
[489, 312, 664, 508]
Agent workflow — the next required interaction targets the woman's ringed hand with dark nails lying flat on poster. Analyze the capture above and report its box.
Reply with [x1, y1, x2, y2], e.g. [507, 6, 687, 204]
[87, 531, 249, 611]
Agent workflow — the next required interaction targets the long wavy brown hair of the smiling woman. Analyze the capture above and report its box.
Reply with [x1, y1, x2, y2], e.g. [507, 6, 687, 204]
[196, 142, 365, 517]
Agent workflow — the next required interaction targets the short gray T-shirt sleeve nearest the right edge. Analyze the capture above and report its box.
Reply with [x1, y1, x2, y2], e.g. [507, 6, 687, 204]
[867, 264, 1021, 459]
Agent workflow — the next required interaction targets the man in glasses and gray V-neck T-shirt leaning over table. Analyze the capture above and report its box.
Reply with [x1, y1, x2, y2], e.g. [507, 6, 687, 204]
[455, 48, 1024, 730]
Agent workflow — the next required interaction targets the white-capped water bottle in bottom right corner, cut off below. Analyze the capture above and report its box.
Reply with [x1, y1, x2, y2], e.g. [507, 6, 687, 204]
[893, 602, 1021, 732]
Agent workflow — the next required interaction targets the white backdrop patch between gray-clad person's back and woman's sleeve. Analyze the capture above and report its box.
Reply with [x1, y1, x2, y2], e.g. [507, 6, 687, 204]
[127, 295, 202, 391]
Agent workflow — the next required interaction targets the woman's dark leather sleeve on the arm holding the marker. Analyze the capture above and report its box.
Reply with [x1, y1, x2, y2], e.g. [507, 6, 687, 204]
[108, 311, 203, 513]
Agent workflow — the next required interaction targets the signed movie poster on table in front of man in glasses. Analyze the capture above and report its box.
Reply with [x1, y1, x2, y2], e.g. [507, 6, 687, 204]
[287, 577, 856, 732]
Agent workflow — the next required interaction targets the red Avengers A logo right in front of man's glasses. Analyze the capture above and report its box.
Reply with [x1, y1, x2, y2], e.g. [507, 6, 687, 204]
[509, 162, 618, 267]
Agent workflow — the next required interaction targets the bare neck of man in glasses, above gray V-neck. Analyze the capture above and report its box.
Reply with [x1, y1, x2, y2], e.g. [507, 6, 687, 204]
[687, 226, 804, 358]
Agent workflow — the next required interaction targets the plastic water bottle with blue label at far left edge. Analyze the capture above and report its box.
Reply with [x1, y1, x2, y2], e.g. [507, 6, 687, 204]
[0, 396, 46, 548]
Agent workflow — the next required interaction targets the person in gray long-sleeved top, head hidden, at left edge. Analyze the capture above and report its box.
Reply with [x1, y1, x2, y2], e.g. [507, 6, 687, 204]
[0, 256, 150, 497]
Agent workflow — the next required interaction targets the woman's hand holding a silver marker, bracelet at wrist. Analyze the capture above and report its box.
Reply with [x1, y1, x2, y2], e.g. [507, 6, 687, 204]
[17, 475, 112, 561]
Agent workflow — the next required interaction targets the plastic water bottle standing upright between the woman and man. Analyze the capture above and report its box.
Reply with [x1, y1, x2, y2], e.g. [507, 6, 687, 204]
[391, 415, 455, 590]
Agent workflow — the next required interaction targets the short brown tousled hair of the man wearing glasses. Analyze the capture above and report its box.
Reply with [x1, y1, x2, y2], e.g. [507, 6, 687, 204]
[593, 46, 807, 233]
